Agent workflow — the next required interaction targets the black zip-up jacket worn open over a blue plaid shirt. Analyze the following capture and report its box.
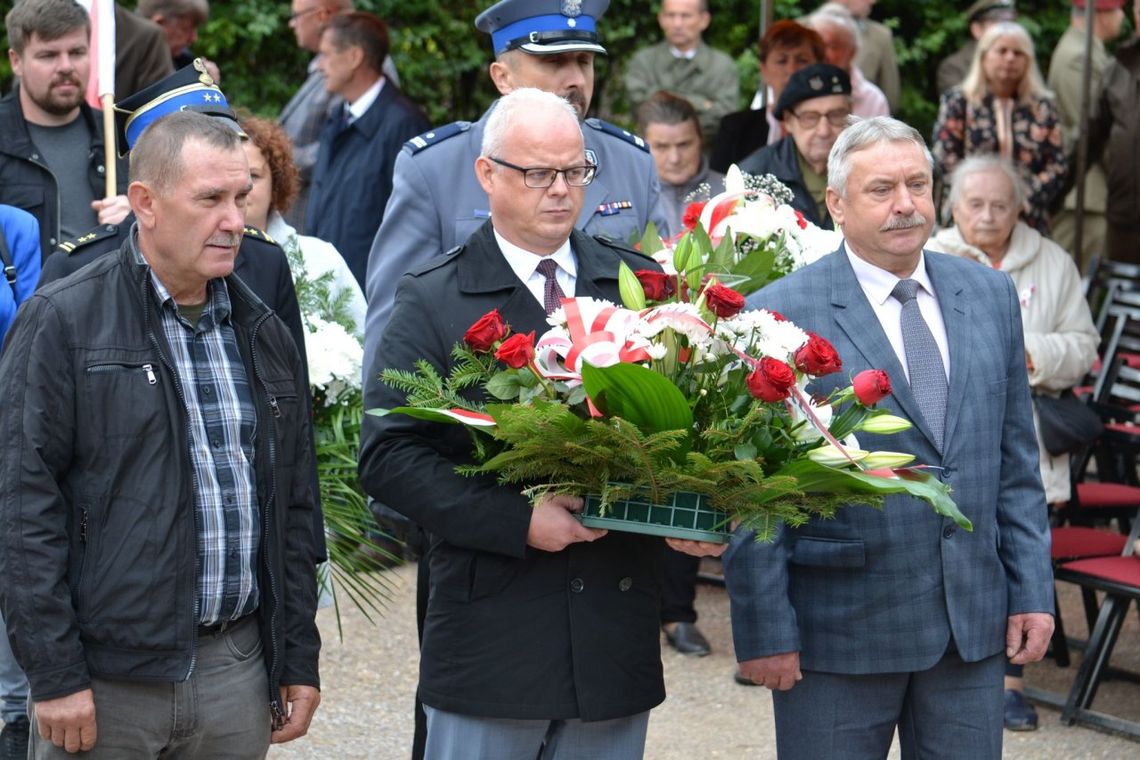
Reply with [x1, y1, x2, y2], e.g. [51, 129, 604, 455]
[0, 243, 320, 710]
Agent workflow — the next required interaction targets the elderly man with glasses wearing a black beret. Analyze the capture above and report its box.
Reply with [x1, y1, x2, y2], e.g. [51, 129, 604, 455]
[740, 64, 852, 229]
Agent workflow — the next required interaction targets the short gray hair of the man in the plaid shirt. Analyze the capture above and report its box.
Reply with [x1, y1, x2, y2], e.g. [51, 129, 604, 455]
[130, 111, 242, 196]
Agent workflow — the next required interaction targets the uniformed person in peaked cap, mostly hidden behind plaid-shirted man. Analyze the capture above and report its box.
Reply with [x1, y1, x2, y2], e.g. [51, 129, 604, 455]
[40, 60, 306, 358]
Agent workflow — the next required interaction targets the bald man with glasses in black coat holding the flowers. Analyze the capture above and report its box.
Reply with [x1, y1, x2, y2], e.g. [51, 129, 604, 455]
[360, 88, 723, 760]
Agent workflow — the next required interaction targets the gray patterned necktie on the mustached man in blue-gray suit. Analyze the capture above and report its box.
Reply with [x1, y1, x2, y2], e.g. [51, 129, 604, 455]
[890, 279, 947, 451]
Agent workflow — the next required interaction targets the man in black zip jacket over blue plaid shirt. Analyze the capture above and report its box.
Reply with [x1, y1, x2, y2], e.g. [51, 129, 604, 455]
[0, 113, 320, 759]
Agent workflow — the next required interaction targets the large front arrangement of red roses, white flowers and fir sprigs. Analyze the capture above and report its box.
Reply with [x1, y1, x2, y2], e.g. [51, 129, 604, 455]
[369, 181, 969, 538]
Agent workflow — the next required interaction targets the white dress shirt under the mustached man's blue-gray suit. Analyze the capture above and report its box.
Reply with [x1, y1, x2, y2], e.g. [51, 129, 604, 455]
[844, 245, 950, 382]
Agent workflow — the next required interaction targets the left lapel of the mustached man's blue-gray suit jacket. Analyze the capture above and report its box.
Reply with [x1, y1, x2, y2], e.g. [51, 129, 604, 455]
[830, 245, 939, 447]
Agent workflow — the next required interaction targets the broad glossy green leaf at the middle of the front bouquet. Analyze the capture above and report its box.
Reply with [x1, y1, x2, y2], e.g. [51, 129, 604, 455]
[581, 363, 693, 433]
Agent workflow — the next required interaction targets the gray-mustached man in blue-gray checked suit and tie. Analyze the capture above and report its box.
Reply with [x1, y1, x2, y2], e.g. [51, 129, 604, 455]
[725, 117, 1053, 760]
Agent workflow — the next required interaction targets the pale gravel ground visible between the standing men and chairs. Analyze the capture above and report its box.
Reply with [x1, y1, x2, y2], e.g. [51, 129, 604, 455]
[269, 566, 1140, 760]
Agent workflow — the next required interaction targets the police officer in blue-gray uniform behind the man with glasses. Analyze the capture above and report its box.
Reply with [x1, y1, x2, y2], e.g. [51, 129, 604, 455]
[365, 0, 669, 364]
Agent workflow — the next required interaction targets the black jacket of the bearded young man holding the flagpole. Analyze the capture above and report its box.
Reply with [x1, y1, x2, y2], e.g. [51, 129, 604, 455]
[0, 85, 128, 259]
